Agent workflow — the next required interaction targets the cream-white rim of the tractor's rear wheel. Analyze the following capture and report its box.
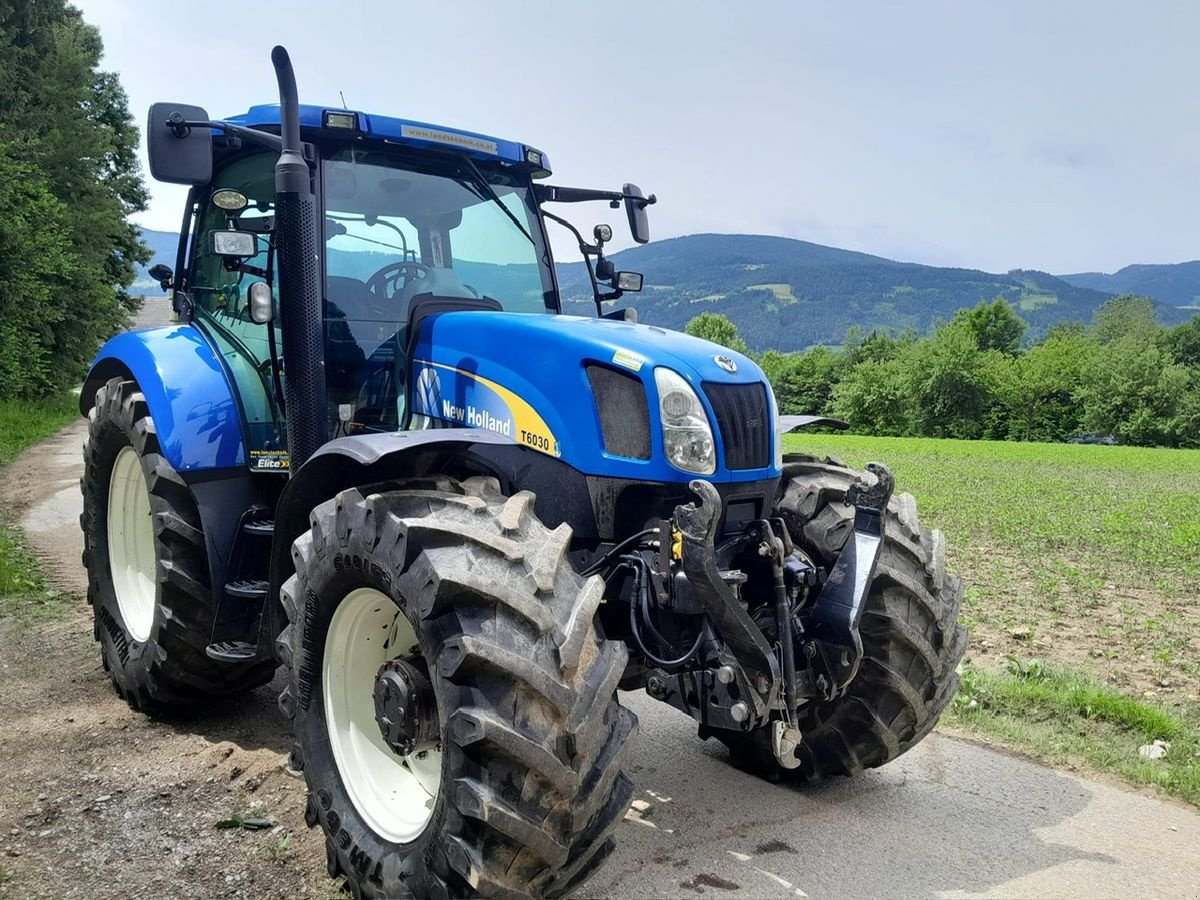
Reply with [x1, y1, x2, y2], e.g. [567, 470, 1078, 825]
[108, 446, 158, 642]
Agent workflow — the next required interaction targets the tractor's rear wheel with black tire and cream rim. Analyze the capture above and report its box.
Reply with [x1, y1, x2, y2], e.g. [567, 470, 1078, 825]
[79, 378, 275, 713]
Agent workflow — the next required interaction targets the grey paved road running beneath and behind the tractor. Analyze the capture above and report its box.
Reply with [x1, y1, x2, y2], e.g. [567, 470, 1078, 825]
[5, 426, 1200, 898]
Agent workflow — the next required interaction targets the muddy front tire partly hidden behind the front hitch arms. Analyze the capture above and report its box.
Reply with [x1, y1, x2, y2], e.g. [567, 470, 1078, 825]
[726, 456, 967, 781]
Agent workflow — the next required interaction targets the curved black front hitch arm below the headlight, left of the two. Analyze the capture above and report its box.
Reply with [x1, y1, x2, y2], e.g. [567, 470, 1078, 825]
[674, 479, 780, 727]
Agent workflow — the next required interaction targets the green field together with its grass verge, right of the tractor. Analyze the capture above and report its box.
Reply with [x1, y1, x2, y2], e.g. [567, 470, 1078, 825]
[786, 434, 1200, 804]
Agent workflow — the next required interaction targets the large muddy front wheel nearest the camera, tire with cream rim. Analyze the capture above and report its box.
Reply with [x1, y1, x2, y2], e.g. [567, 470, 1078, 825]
[276, 478, 637, 898]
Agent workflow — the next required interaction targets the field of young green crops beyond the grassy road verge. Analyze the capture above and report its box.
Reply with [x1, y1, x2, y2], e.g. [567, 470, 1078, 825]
[787, 434, 1200, 703]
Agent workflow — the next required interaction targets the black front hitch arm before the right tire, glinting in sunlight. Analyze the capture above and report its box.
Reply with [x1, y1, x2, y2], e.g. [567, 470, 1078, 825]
[804, 462, 895, 700]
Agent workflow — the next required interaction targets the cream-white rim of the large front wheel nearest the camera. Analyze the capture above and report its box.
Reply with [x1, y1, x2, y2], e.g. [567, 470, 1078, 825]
[322, 588, 442, 844]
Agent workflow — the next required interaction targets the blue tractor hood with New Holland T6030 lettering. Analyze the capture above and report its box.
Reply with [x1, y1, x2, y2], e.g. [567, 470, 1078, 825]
[412, 311, 780, 482]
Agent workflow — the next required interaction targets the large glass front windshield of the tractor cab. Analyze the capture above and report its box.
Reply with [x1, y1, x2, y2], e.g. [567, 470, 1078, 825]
[322, 146, 558, 433]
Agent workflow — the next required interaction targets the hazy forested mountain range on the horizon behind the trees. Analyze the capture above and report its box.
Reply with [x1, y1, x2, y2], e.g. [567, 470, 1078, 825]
[134, 230, 1200, 350]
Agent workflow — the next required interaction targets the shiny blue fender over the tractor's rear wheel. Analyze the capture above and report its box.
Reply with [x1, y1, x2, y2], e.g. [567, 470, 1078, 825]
[91, 325, 246, 472]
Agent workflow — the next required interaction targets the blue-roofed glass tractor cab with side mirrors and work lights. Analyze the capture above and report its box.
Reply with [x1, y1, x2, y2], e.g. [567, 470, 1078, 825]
[149, 103, 653, 472]
